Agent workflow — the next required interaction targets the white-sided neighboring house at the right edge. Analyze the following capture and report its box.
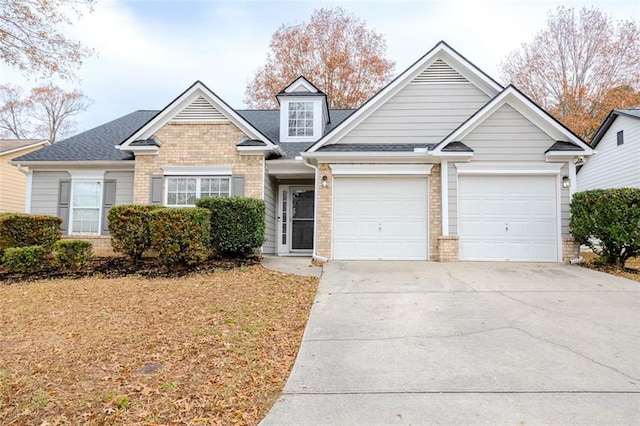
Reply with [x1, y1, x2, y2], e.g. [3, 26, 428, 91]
[578, 109, 640, 191]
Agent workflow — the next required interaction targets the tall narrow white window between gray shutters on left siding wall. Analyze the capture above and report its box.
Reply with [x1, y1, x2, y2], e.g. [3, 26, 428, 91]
[71, 180, 102, 234]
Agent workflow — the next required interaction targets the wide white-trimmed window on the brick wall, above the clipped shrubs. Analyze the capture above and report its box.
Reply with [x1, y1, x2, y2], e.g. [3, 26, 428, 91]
[166, 176, 231, 207]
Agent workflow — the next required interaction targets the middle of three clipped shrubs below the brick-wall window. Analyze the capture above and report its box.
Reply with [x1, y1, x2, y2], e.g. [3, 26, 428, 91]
[150, 208, 211, 268]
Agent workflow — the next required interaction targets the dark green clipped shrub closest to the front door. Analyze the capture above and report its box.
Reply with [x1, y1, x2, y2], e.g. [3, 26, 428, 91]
[196, 197, 265, 257]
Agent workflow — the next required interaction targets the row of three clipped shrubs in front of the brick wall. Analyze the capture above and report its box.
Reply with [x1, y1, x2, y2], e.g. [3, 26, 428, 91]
[108, 197, 265, 267]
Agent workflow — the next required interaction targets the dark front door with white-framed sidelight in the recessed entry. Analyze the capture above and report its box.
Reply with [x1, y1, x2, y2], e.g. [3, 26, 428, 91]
[278, 185, 315, 253]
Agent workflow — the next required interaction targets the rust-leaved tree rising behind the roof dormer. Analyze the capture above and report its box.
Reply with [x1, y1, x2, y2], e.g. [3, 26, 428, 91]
[245, 7, 395, 108]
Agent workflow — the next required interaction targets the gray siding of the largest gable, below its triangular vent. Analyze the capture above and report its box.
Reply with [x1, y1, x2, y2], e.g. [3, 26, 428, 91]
[339, 82, 489, 144]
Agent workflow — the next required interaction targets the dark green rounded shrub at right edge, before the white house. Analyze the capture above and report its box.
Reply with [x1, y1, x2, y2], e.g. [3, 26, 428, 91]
[569, 188, 640, 267]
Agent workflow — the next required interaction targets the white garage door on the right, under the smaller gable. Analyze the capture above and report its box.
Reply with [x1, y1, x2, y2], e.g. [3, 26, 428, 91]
[458, 175, 558, 262]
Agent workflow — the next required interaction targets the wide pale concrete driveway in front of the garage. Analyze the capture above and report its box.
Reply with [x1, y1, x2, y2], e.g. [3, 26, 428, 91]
[262, 262, 640, 425]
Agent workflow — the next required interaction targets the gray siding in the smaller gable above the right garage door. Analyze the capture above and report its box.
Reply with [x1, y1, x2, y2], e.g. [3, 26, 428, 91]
[462, 105, 555, 162]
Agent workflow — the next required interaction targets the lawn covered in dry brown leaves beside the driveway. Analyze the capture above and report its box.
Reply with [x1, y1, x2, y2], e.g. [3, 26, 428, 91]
[0, 266, 317, 424]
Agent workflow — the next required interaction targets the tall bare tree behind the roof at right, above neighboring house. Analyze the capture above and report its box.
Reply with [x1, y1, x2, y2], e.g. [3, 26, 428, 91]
[502, 6, 640, 139]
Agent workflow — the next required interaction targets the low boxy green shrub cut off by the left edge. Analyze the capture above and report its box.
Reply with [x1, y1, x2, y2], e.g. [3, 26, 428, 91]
[0, 213, 62, 254]
